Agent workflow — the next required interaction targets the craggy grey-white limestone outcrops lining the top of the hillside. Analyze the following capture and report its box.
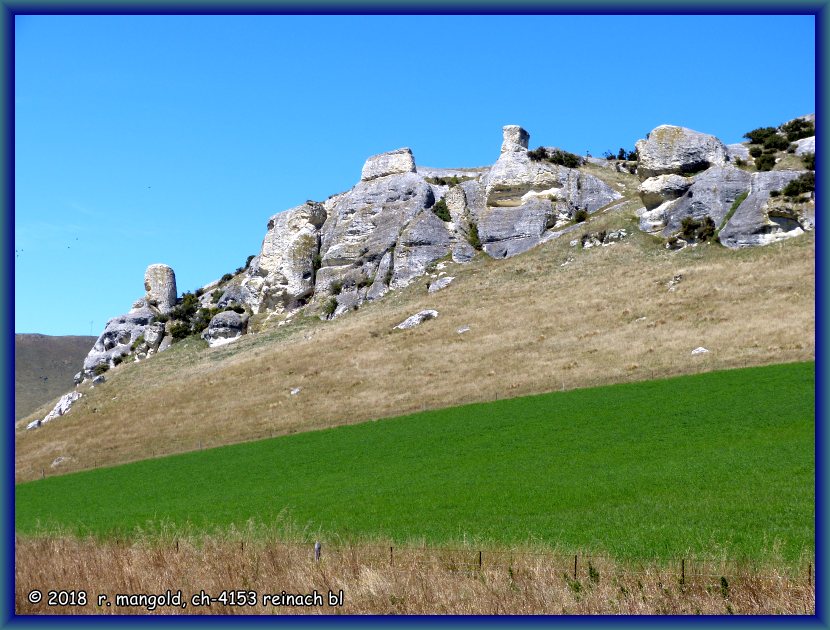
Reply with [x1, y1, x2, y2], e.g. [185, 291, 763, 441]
[55, 117, 815, 414]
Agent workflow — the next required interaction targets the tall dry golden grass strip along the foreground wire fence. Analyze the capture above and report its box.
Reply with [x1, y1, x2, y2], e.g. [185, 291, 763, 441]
[15, 537, 816, 615]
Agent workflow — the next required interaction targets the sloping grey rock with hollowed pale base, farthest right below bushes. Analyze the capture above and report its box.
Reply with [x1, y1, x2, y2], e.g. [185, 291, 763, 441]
[718, 171, 812, 249]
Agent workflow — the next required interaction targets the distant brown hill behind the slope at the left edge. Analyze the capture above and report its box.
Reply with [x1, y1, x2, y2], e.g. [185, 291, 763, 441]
[14, 334, 96, 421]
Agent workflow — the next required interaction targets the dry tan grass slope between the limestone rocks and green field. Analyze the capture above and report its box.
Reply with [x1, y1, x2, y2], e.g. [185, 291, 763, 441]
[16, 204, 815, 481]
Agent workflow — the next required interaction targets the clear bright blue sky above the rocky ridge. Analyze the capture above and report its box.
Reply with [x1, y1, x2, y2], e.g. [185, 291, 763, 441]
[14, 15, 815, 335]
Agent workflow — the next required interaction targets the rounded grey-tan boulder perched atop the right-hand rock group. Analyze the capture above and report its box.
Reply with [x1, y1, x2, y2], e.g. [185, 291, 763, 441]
[636, 125, 728, 181]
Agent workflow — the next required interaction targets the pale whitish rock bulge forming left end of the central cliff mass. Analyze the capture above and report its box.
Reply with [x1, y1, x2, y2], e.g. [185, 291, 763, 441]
[242, 201, 326, 313]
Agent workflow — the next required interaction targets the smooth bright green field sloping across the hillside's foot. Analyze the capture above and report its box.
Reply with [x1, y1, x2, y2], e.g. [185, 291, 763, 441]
[15, 362, 815, 561]
